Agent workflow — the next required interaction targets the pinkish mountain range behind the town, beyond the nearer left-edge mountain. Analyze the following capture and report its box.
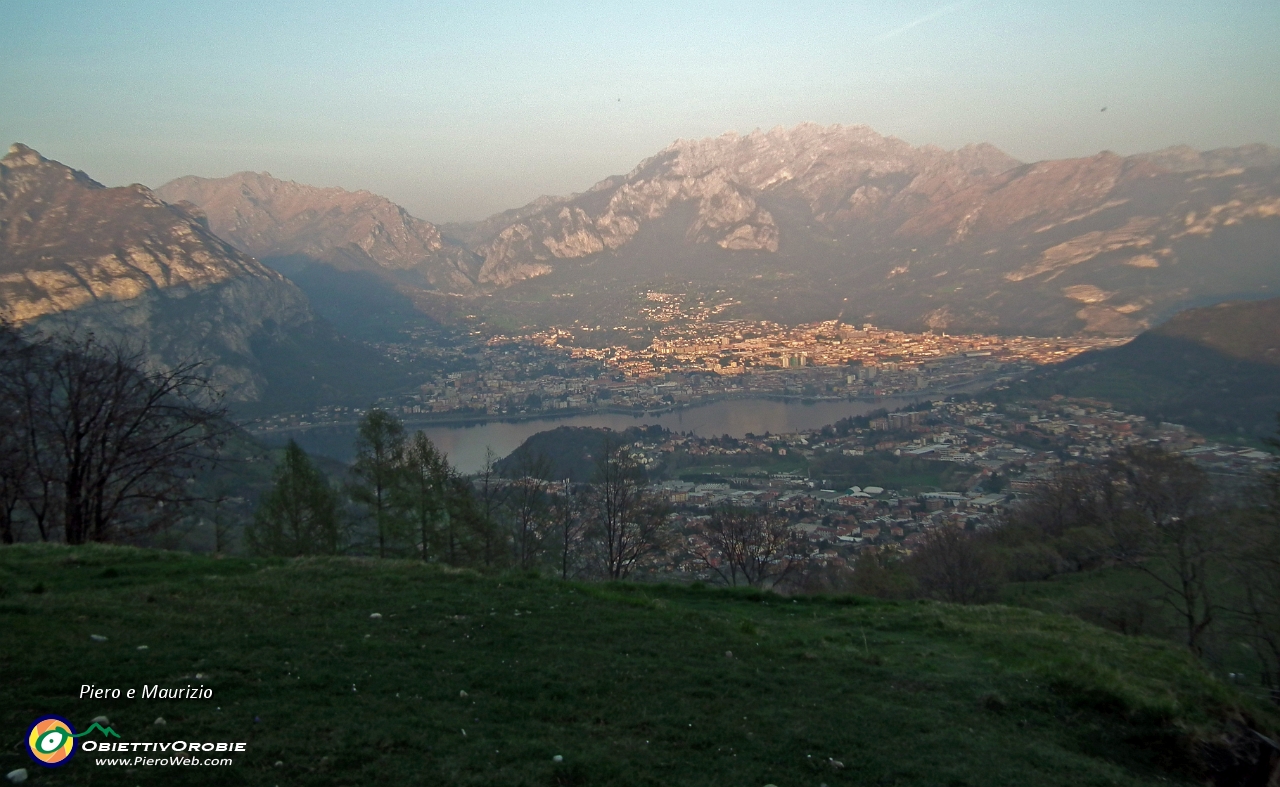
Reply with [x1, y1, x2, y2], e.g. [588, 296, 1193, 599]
[157, 124, 1280, 335]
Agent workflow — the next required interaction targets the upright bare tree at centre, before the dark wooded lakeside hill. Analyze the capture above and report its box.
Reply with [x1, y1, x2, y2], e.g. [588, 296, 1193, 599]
[588, 438, 668, 580]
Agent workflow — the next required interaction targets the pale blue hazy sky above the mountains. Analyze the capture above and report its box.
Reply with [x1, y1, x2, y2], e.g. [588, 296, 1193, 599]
[0, 0, 1280, 221]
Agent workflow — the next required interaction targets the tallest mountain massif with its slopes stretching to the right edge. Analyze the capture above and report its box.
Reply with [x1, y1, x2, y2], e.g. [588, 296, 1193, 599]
[451, 124, 1280, 334]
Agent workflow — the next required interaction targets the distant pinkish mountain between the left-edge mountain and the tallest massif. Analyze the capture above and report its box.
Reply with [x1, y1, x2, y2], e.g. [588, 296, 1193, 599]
[156, 173, 480, 292]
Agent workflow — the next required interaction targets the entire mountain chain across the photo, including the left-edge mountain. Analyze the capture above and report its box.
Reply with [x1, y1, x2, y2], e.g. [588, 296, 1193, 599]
[0, 124, 1280, 406]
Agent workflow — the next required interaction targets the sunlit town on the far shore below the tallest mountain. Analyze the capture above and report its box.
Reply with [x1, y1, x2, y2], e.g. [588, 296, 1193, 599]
[251, 293, 1128, 430]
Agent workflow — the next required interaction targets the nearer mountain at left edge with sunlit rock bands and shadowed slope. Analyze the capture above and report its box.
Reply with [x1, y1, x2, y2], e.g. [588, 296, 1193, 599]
[0, 145, 314, 401]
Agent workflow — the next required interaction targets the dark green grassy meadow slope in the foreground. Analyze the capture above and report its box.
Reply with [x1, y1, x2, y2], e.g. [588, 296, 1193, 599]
[0, 545, 1275, 787]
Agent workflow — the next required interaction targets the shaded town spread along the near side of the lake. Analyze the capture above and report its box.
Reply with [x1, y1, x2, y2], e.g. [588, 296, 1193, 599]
[631, 397, 1272, 578]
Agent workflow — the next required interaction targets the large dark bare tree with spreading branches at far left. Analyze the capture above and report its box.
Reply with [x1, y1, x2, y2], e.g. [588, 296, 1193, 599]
[15, 333, 232, 544]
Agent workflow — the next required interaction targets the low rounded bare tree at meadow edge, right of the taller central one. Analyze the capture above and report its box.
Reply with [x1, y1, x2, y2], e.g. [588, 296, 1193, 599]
[694, 507, 805, 587]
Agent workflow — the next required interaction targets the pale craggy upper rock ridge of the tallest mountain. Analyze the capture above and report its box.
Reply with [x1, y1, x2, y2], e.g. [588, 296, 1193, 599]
[474, 124, 1018, 287]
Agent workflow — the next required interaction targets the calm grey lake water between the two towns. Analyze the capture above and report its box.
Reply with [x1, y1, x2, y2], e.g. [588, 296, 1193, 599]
[254, 394, 937, 472]
